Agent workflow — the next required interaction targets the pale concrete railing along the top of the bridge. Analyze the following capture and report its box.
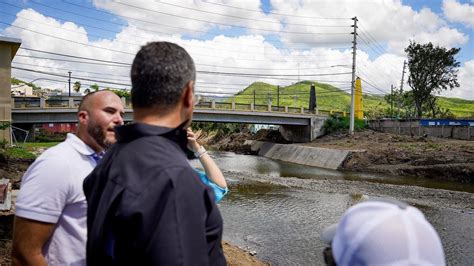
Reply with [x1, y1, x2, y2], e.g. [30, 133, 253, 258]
[12, 97, 347, 116]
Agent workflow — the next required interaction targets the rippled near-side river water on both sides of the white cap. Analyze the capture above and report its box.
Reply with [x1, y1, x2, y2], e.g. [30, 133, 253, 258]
[220, 179, 474, 265]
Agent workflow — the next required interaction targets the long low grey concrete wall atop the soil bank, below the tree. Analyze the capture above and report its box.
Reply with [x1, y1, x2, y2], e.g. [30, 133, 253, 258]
[369, 120, 474, 140]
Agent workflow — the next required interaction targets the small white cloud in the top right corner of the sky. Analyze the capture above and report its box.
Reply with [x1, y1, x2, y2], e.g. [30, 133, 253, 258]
[442, 0, 474, 28]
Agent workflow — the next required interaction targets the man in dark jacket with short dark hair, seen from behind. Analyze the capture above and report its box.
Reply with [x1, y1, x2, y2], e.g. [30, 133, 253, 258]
[84, 42, 226, 265]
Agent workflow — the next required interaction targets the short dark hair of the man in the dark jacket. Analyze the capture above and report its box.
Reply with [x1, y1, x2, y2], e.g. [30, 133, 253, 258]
[131, 42, 196, 109]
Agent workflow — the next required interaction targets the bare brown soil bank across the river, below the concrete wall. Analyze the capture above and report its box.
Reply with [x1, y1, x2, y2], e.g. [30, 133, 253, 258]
[304, 130, 474, 183]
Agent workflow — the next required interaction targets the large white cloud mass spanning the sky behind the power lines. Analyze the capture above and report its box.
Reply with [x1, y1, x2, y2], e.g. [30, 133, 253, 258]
[4, 0, 474, 101]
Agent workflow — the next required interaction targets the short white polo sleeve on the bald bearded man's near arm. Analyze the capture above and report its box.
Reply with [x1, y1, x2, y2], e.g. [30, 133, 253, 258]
[15, 156, 70, 223]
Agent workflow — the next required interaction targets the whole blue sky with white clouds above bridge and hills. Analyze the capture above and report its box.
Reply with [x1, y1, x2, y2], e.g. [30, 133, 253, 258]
[0, 0, 474, 99]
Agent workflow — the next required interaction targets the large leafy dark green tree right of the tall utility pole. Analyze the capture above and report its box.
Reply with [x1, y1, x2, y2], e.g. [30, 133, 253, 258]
[405, 41, 460, 118]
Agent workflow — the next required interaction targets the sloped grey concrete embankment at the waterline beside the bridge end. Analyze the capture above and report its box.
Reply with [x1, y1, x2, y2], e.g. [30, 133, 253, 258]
[245, 141, 351, 170]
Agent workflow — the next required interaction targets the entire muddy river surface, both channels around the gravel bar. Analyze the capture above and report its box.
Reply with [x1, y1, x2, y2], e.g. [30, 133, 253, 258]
[194, 153, 474, 265]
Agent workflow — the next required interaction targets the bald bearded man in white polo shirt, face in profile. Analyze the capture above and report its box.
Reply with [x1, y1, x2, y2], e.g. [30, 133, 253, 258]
[12, 91, 124, 265]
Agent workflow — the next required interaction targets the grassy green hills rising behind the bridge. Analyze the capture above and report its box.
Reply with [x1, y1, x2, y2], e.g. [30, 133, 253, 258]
[228, 81, 474, 118]
